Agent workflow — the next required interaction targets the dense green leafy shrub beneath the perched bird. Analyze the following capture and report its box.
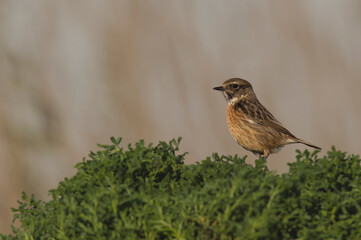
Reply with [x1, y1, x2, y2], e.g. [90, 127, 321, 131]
[2, 138, 361, 240]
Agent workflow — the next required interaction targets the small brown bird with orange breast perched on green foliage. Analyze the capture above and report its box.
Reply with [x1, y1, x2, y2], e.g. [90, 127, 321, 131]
[213, 78, 321, 159]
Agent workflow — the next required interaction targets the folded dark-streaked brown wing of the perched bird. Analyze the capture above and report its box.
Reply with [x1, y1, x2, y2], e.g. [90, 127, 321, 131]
[235, 100, 297, 139]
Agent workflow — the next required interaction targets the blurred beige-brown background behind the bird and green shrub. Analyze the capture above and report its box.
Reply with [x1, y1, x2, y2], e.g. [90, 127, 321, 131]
[0, 0, 361, 233]
